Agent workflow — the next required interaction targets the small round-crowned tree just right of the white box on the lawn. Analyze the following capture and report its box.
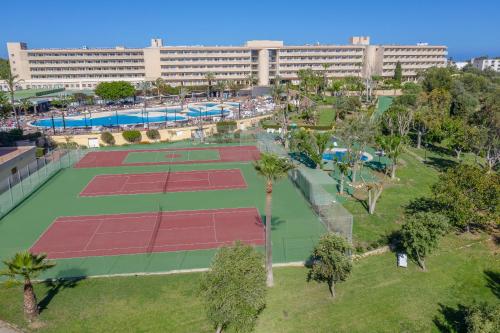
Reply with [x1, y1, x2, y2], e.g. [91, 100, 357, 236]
[401, 212, 448, 271]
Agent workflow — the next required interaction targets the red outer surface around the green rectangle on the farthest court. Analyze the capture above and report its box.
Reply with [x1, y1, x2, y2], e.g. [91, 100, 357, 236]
[75, 146, 260, 168]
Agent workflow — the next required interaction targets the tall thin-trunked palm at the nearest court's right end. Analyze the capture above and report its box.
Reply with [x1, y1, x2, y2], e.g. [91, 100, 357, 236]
[254, 153, 294, 287]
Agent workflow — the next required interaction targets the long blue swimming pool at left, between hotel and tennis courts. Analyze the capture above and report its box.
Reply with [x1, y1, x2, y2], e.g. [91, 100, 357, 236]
[31, 109, 187, 128]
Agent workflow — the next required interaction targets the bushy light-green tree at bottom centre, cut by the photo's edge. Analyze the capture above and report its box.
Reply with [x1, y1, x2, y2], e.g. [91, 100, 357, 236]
[200, 242, 266, 333]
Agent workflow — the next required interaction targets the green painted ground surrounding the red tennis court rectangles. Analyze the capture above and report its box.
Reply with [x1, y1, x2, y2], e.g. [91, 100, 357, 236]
[0, 146, 325, 278]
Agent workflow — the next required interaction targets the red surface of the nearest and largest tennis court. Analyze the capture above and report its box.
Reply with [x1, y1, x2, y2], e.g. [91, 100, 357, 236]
[31, 208, 264, 259]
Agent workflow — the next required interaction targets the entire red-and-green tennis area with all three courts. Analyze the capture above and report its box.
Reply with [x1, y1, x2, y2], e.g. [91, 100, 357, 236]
[0, 143, 324, 279]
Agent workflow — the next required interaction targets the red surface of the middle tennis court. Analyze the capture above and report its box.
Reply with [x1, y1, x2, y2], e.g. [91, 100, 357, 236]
[80, 169, 247, 197]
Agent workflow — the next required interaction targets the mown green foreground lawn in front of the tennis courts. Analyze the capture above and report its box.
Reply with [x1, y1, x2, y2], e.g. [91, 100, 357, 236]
[0, 235, 500, 333]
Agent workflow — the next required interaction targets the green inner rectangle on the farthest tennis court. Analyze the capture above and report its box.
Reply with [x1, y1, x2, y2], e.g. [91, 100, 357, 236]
[123, 149, 220, 164]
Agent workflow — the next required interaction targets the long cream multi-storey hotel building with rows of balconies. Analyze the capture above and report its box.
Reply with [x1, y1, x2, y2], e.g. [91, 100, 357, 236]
[0, 37, 447, 90]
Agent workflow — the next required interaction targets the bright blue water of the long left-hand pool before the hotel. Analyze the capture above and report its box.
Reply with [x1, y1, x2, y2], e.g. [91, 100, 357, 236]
[33, 110, 186, 127]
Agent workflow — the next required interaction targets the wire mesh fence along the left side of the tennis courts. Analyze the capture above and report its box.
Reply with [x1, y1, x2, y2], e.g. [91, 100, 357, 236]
[0, 148, 91, 219]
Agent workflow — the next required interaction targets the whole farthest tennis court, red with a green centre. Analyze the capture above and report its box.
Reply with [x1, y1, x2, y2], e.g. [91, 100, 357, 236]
[75, 146, 260, 168]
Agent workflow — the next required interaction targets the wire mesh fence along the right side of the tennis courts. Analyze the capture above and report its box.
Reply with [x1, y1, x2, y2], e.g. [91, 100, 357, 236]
[257, 132, 353, 243]
